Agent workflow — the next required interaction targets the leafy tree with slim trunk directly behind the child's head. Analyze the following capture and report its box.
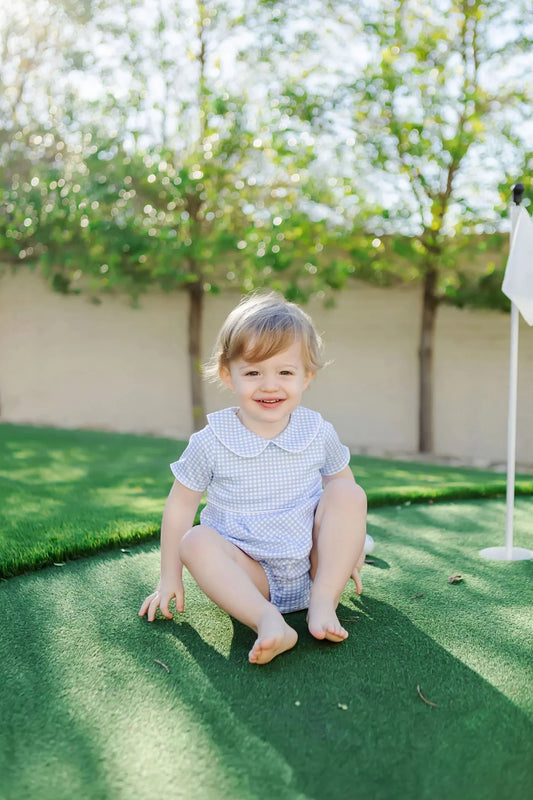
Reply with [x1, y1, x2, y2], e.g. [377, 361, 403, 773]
[2, 0, 356, 429]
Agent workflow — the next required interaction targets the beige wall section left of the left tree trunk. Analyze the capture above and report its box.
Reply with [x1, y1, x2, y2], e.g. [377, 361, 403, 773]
[0, 272, 189, 435]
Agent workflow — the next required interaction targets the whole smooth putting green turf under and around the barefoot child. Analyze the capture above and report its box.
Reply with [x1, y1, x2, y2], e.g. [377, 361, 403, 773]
[0, 498, 533, 800]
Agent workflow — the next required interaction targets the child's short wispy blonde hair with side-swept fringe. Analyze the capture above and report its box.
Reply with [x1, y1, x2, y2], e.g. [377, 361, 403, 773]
[204, 292, 324, 380]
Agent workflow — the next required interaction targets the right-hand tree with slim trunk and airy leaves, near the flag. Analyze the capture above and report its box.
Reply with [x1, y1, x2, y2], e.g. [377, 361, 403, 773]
[332, 0, 532, 451]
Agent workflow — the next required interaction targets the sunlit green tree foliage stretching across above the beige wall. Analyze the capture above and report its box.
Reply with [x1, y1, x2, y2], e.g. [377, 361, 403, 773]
[0, 0, 531, 316]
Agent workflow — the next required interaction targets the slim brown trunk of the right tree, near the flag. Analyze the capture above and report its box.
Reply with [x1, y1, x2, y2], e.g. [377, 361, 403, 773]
[418, 267, 438, 453]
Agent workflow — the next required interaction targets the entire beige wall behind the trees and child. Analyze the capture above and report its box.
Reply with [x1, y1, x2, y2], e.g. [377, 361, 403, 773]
[0, 271, 533, 464]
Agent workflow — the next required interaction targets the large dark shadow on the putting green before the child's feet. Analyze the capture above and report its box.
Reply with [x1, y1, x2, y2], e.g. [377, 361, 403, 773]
[162, 598, 533, 800]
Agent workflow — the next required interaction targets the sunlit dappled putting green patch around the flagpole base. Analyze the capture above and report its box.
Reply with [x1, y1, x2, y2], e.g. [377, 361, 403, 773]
[365, 498, 533, 680]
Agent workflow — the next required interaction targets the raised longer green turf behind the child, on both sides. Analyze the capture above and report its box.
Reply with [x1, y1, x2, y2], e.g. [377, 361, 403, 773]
[4, 424, 533, 577]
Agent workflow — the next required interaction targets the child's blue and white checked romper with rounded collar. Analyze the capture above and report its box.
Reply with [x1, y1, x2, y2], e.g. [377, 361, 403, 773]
[170, 406, 350, 613]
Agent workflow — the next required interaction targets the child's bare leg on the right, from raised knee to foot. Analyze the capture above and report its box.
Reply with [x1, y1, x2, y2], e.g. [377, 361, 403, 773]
[307, 478, 366, 642]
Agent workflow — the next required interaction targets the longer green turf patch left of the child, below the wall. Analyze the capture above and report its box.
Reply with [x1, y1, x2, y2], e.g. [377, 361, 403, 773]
[0, 424, 184, 577]
